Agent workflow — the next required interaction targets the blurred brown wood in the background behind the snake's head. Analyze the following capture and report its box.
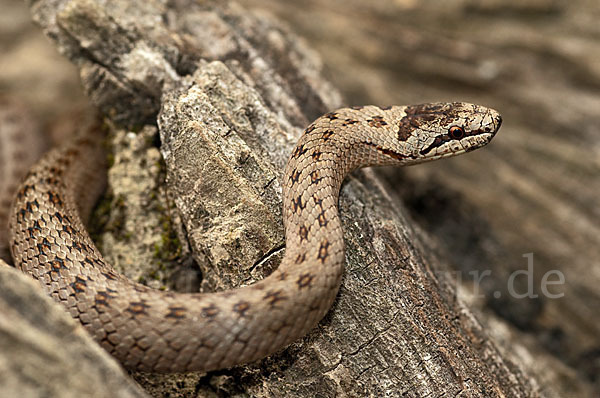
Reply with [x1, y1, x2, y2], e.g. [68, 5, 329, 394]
[237, 0, 600, 397]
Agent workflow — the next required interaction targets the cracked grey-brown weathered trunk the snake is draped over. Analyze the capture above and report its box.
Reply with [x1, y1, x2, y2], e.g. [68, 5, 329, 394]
[4, 0, 539, 397]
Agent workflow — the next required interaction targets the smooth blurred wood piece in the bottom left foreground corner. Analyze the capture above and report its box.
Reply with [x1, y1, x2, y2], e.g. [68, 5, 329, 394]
[0, 259, 147, 398]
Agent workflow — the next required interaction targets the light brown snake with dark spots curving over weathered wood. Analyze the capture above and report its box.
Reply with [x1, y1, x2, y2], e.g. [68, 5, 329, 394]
[9, 102, 502, 373]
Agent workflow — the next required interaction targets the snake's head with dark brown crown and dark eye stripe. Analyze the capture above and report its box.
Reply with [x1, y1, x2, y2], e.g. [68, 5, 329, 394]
[398, 102, 502, 163]
